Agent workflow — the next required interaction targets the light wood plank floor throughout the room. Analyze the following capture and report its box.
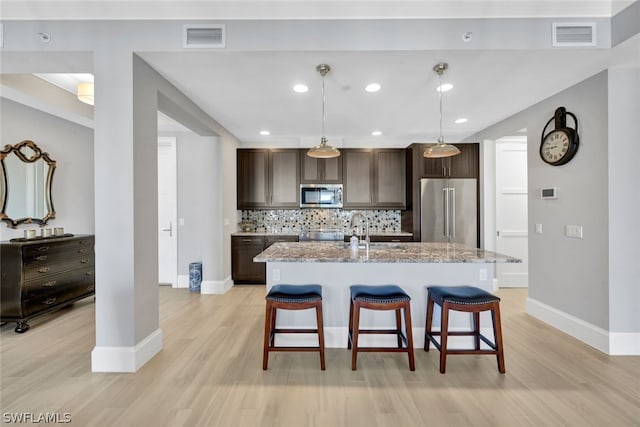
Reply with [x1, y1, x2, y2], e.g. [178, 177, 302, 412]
[0, 286, 640, 427]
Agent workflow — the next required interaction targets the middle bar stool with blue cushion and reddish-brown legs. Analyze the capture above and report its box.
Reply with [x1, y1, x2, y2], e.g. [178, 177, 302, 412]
[347, 285, 416, 371]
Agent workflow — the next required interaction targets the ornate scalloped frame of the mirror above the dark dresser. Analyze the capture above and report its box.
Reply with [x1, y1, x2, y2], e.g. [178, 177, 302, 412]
[0, 140, 56, 228]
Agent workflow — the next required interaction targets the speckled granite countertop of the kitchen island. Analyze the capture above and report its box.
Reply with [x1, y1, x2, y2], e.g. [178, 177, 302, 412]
[253, 242, 522, 263]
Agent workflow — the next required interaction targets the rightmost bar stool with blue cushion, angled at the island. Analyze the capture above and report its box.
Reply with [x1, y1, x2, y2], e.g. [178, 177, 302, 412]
[424, 286, 506, 374]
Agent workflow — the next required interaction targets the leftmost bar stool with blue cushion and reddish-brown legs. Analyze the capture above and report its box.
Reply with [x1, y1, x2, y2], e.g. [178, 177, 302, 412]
[262, 285, 325, 371]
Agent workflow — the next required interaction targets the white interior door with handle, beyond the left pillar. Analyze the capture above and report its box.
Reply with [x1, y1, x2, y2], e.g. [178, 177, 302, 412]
[158, 138, 178, 288]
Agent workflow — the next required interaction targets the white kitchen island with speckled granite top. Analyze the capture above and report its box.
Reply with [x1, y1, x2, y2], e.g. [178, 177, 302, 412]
[254, 242, 520, 348]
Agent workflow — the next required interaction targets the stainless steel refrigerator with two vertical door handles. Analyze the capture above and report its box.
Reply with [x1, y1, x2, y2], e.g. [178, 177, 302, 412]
[420, 178, 478, 248]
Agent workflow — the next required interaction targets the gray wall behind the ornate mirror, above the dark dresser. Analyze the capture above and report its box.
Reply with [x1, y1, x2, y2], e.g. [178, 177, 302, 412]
[0, 98, 94, 240]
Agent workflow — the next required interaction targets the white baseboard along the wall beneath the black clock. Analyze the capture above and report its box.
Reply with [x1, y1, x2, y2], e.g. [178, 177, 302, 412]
[527, 298, 611, 354]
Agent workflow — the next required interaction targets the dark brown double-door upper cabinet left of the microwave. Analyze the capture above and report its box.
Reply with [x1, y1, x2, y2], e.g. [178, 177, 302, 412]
[237, 149, 300, 209]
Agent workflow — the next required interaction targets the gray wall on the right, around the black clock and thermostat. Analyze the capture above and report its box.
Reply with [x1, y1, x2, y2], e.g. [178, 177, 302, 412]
[470, 67, 640, 340]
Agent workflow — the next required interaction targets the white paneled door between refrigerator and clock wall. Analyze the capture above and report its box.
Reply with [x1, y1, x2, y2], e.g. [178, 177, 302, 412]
[496, 140, 529, 288]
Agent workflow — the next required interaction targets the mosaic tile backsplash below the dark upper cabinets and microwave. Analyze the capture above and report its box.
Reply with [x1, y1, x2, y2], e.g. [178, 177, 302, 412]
[240, 209, 401, 234]
